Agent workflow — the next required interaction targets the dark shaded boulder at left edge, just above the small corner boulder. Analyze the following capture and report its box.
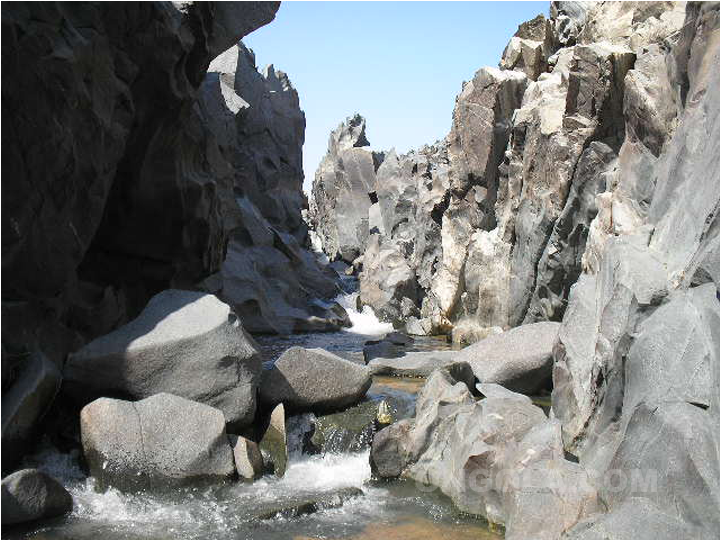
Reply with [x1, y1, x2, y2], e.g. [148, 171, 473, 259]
[2, 352, 62, 470]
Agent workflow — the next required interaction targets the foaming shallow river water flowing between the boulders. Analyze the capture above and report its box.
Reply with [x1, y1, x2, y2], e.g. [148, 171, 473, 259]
[2, 294, 499, 540]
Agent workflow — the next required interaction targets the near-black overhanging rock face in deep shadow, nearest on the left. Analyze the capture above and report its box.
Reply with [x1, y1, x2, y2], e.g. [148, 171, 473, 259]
[2, 2, 279, 368]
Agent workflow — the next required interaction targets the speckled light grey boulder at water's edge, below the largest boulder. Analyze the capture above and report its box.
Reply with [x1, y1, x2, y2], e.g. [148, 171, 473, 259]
[80, 393, 235, 491]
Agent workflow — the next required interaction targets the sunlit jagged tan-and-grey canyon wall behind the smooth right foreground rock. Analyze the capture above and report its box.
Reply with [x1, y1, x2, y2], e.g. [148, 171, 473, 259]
[311, 2, 712, 341]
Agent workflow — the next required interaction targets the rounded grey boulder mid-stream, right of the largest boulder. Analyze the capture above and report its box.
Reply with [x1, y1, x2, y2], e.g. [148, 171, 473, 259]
[260, 347, 372, 412]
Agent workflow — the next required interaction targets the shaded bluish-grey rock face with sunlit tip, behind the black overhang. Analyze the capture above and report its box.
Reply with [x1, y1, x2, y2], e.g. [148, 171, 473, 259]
[200, 43, 348, 334]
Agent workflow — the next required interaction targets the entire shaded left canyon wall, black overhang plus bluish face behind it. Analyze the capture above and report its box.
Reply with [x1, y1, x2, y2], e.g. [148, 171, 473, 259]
[2, 2, 346, 466]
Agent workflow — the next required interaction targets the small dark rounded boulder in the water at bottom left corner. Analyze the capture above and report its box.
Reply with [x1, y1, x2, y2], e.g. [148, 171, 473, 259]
[2, 469, 73, 525]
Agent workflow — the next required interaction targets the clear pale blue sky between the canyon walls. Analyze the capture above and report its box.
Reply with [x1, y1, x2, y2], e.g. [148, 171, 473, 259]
[243, 2, 550, 191]
